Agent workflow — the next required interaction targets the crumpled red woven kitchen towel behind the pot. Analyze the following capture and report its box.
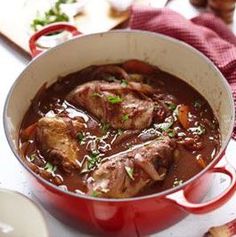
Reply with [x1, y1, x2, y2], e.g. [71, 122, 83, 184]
[129, 6, 236, 139]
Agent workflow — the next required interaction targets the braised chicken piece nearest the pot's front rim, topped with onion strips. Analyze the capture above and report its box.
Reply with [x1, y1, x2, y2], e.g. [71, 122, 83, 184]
[88, 137, 175, 198]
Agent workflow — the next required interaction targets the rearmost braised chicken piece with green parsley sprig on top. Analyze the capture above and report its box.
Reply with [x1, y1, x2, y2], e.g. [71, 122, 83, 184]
[67, 81, 156, 130]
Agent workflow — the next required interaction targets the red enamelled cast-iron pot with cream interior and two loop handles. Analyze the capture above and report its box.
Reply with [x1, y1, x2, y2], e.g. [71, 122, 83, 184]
[4, 24, 236, 237]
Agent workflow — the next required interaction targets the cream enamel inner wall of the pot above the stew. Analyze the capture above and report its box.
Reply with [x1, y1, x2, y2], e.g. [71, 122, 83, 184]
[4, 31, 234, 214]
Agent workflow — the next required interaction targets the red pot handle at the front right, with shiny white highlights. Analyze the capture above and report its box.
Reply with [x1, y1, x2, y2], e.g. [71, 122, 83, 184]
[167, 166, 236, 214]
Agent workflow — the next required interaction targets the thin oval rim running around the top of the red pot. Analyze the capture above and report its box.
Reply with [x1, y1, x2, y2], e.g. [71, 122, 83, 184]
[3, 30, 235, 203]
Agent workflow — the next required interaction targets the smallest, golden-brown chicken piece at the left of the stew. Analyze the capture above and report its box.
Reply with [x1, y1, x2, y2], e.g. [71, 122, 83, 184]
[37, 117, 83, 173]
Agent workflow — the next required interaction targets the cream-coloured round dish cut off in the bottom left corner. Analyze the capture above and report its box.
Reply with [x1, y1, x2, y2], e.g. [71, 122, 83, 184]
[0, 189, 49, 237]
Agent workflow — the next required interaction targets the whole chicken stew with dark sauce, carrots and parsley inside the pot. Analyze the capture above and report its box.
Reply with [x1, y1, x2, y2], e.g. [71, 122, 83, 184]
[19, 60, 221, 198]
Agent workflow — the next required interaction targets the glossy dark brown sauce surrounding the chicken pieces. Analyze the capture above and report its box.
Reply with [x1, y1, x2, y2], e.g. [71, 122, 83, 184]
[19, 63, 220, 195]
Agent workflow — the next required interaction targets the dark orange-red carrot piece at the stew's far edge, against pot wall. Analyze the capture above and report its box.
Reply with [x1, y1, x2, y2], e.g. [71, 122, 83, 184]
[122, 59, 155, 74]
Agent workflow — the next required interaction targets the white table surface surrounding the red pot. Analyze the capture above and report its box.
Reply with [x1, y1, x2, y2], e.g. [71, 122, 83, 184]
[0, 0, 236, 237]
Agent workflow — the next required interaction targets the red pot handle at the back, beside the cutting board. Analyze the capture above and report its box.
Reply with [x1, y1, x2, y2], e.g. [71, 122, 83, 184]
[29, 23, 81, 57]
